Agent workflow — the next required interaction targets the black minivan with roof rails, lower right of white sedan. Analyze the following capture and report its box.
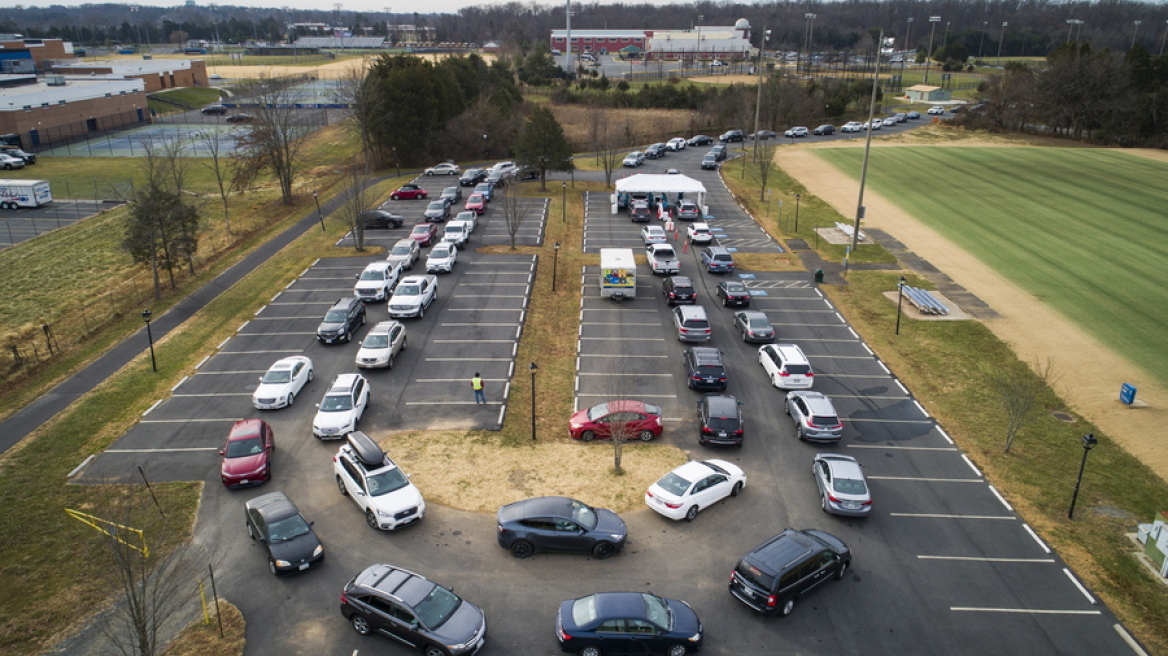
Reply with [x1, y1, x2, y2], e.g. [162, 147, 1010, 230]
[730, 529, 851, 616]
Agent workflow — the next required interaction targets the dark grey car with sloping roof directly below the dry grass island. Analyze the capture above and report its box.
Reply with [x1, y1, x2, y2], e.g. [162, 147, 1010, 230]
[496, 496, 628, 559]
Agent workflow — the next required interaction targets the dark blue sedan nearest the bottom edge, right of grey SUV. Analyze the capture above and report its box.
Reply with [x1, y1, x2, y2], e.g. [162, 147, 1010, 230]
[556, 592, 702, 656]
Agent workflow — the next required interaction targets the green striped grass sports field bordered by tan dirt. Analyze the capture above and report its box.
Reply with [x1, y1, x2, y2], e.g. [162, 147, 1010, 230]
[818, 147, 1168, 385]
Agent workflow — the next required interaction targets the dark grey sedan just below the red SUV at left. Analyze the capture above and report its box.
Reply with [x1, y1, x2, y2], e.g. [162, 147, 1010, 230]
[244, 493, 325, 574]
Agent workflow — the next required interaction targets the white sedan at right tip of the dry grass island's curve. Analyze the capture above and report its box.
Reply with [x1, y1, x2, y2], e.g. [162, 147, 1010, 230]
[645, 460, 746, 522]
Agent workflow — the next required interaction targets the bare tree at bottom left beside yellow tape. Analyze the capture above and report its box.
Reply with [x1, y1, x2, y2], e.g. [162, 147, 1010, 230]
[77, 473, 209, 656]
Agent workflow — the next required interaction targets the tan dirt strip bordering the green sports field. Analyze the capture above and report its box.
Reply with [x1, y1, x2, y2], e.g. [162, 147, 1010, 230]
[776, 134, 1168, 480]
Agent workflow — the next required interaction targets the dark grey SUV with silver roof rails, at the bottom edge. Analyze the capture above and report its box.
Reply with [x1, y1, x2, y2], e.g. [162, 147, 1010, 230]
[341, 565, 487, 656]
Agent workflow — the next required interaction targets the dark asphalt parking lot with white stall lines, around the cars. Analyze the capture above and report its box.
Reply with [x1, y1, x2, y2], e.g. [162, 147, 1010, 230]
[70, 151, 1127, 656]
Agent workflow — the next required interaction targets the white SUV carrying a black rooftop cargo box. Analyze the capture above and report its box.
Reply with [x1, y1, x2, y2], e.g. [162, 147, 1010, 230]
[333, 431, 426, 531]
